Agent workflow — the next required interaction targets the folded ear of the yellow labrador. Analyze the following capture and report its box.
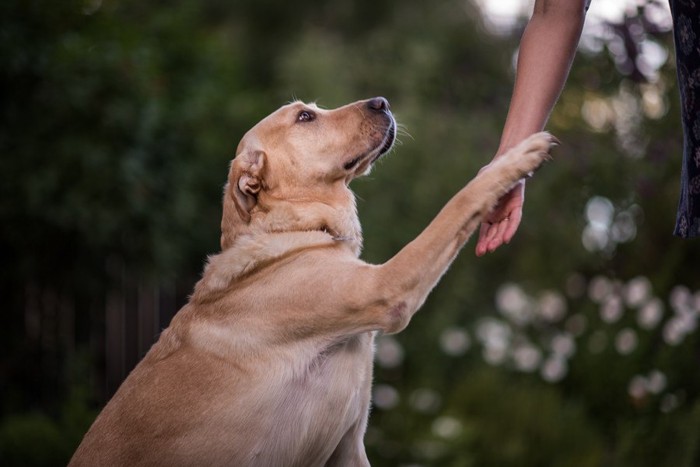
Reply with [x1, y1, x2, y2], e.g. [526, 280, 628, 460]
[228, 151, 265, 222]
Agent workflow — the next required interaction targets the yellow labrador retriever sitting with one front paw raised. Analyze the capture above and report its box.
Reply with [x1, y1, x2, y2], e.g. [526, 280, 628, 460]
[71, 98, 554, 467]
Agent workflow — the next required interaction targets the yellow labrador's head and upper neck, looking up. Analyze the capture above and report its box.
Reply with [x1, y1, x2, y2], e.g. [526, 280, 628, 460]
[221, 97, 396, 249]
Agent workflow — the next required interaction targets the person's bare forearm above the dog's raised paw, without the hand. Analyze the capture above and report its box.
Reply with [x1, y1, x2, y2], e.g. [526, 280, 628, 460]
[497, 0, 585, 155]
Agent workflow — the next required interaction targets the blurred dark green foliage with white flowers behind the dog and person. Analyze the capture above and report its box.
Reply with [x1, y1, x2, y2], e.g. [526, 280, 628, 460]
[0, 0, 700, 467]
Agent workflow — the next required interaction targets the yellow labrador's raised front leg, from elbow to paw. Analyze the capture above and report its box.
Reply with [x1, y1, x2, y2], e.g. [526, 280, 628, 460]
[360, 133, 556, 333]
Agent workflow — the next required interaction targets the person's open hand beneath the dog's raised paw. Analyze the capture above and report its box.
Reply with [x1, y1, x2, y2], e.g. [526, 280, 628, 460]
[476, 180, 525, 256]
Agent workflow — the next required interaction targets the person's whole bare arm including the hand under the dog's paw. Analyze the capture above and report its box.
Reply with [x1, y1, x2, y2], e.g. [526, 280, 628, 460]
[476, 0, 586, 256]
